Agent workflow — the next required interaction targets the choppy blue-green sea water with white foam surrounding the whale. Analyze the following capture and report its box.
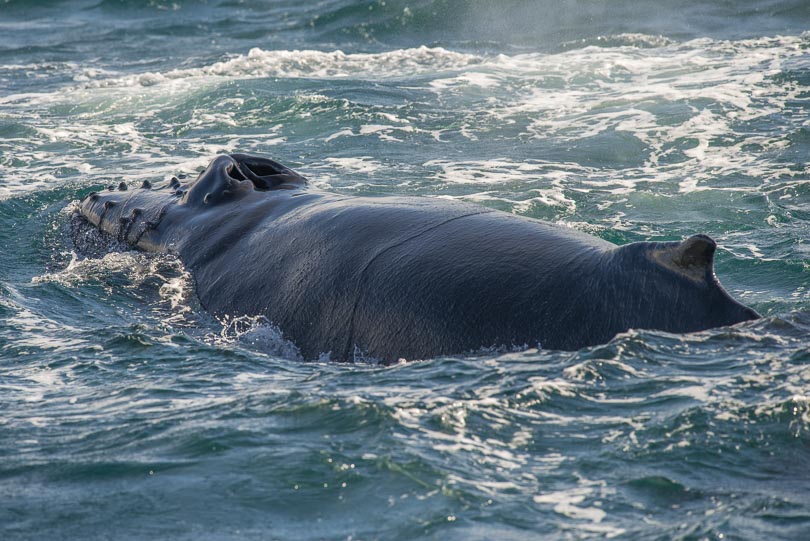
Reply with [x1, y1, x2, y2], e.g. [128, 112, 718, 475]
[0, 0, 810, 541]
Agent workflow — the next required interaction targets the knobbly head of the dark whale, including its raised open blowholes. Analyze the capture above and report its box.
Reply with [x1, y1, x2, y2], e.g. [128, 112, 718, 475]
[79, 154, 307, 250]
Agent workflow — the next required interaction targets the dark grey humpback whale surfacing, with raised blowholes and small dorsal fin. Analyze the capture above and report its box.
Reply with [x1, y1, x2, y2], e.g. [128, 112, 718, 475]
[80, 154, 759, 362]
